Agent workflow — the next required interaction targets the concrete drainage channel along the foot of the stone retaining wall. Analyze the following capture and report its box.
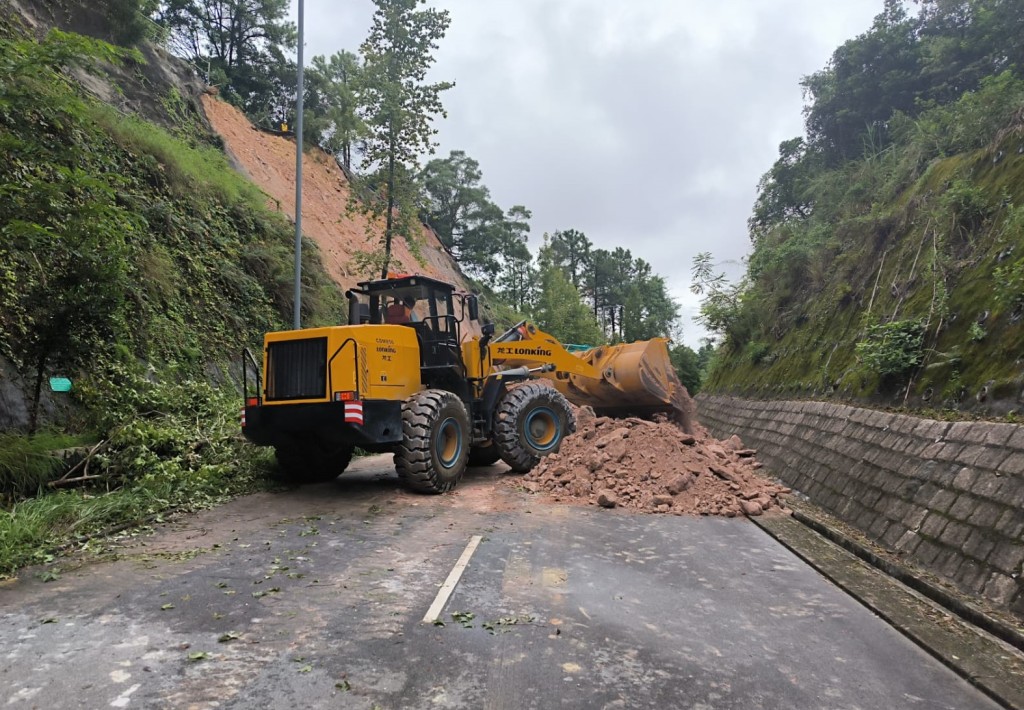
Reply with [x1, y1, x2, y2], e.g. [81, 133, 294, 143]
[750, 505, 1024, 710]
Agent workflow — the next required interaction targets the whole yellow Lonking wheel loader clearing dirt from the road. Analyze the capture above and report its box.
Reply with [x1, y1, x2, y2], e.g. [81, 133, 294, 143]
[242, 276, 689, 493]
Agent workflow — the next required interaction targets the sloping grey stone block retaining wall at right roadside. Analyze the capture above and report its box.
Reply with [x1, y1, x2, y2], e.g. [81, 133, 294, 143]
[697, 395, 1024, 614]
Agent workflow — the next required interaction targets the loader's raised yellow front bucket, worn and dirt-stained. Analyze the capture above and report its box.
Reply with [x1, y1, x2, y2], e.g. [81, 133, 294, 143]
[556, 338, 694, 433]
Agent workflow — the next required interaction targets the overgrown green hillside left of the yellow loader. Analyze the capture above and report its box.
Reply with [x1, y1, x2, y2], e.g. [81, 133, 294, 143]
[0, 19, 344, 577]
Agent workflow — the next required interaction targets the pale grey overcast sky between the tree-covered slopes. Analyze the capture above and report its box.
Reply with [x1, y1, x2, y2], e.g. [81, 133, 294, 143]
[293, 0, 883, 347]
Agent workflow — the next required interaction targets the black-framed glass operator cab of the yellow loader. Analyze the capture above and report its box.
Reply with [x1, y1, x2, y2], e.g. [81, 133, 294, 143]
[350, 276, 476, 399]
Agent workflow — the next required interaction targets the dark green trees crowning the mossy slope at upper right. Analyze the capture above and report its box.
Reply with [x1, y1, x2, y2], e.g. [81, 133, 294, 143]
[803, 0, 1024, 166]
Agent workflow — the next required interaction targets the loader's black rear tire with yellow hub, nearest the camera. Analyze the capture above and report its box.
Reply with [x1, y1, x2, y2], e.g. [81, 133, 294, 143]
[394, 389, 469, 493]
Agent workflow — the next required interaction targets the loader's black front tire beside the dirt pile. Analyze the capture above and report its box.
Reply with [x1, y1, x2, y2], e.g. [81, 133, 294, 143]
[495, 382, 575, 473]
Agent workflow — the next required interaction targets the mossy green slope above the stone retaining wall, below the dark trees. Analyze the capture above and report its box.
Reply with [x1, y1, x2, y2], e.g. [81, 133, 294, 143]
[706, 72, 1024, 415]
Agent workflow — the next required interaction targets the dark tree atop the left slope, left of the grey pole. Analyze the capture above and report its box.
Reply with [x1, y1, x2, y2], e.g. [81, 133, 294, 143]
[158, 0, 297, 115]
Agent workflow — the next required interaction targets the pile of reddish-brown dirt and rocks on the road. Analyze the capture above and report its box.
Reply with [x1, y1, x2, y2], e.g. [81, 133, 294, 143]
[515, 407, 790, 517]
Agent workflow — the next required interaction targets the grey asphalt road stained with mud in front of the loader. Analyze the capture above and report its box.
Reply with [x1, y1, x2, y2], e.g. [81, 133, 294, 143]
[0, 457, 995, 710]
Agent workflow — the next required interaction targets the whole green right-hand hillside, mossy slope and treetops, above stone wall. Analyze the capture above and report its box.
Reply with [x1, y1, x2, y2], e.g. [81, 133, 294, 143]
[693, 0, 1024, 408]
